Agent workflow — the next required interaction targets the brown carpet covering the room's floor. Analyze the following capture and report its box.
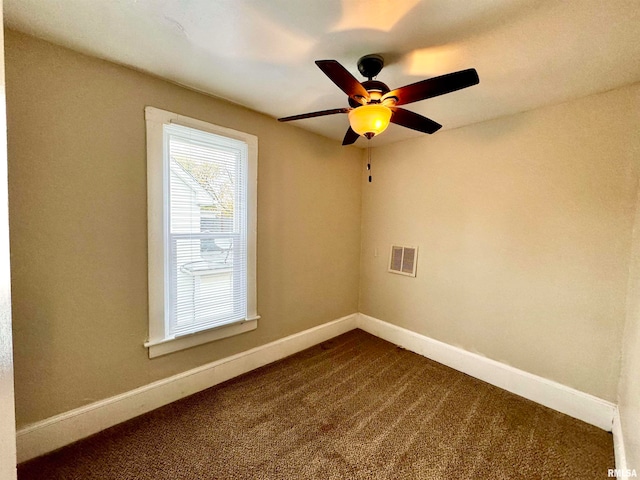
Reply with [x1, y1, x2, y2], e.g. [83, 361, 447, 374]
[18, 330, 614, 480]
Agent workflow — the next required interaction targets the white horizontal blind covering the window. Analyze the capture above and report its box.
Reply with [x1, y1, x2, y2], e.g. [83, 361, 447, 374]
[163, 124, 247, 337]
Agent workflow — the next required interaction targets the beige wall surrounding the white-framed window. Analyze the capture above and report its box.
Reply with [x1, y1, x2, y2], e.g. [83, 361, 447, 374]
[6, 31, 361, 426]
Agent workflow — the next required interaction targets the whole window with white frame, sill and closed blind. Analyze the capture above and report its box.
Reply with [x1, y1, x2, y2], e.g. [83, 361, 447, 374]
[145, 107, 259, 358]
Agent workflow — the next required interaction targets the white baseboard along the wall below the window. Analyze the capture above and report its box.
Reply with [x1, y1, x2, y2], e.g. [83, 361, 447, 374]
[16, 314, 357, 463]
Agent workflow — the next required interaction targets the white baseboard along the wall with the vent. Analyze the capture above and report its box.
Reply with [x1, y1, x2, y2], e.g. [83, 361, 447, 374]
[357, 313, 616, 432]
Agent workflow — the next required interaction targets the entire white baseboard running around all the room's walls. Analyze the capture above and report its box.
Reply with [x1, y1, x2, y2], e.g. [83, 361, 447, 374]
[17, 313, 625, 468]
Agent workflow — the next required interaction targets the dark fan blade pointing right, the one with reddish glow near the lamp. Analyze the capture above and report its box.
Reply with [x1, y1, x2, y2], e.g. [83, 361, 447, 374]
[381, 68, 480, 105]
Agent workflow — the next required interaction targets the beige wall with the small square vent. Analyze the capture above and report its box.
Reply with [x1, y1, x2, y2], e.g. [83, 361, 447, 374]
[360, 84, 640, 401]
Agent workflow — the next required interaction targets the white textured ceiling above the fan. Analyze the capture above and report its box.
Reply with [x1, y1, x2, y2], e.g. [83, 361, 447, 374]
[4, 0, 640, 146]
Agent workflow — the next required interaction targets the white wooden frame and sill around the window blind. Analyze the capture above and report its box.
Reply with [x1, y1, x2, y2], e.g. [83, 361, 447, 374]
[144, 106, 260, 358]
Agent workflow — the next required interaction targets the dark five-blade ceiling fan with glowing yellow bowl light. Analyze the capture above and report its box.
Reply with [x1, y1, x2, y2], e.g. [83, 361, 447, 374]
[278, 54, 480, 145]
